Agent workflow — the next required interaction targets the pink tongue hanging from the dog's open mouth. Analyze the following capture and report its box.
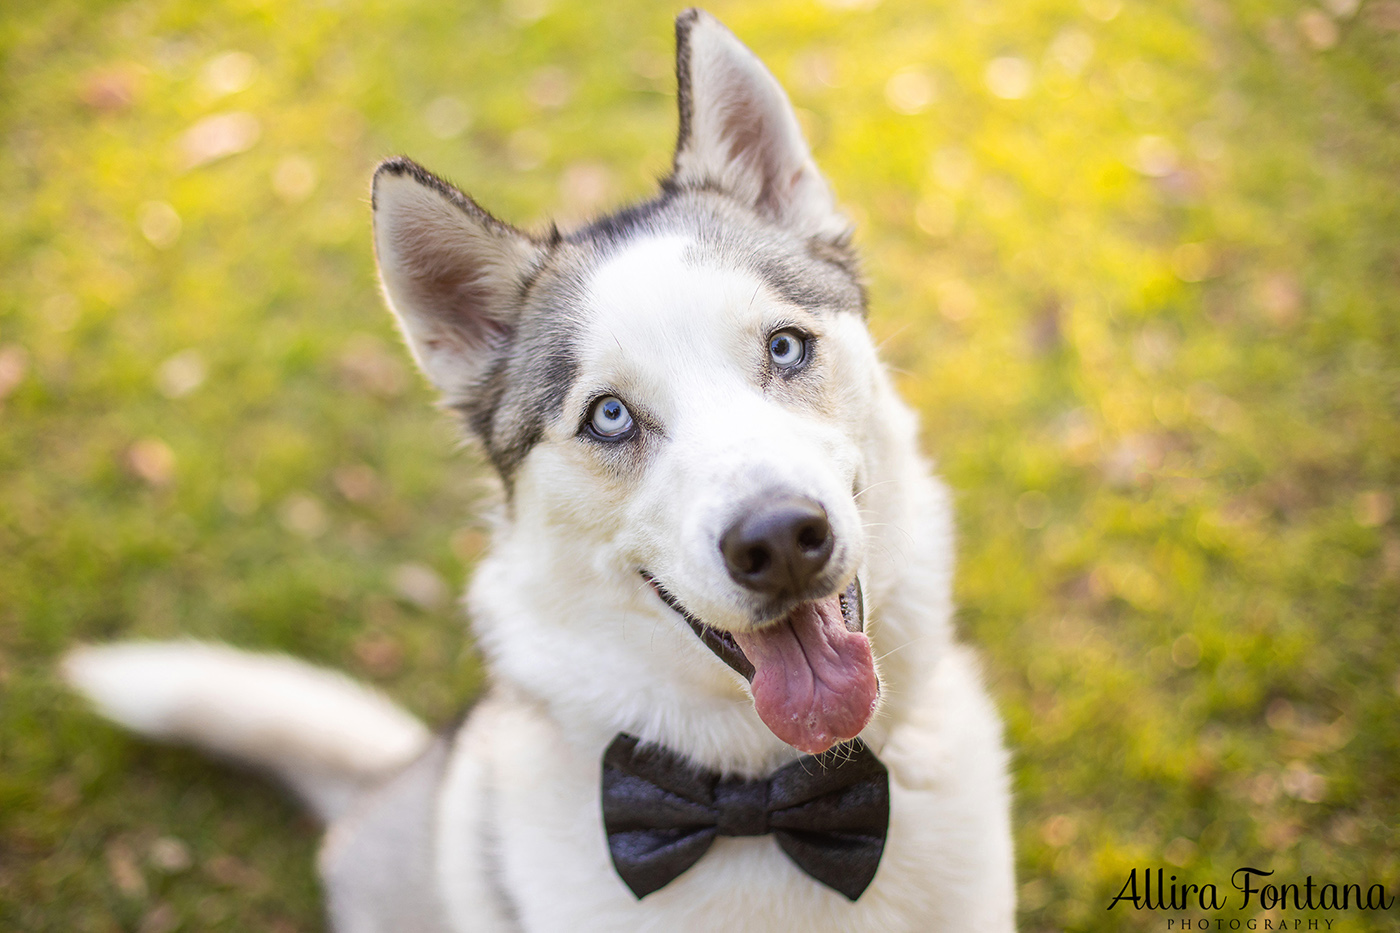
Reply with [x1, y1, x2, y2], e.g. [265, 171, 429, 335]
[734, 595, 879, 755]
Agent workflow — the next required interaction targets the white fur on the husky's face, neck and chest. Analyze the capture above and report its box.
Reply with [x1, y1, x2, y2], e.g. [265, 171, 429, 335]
[438, 237, 1015, 932]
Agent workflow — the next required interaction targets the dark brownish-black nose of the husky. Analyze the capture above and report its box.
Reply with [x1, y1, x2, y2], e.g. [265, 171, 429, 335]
[720, 496, 836, 595]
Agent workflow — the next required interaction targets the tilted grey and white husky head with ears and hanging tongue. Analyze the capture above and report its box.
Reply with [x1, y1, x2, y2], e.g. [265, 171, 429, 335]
[374, 10, 901, 752]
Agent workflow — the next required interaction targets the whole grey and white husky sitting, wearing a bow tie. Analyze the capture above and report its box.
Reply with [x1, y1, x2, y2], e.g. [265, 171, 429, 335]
[66, 10, 1015, 933]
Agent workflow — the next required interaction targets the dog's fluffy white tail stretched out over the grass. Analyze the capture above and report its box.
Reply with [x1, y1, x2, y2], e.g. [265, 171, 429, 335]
[63, 642, 431, 822]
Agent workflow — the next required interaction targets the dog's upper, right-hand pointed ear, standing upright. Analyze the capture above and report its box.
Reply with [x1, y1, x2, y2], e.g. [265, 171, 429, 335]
[671, 10, 850, 240]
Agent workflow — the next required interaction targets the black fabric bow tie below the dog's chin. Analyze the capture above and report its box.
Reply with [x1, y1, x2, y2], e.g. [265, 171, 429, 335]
[603, 733, 889, 901]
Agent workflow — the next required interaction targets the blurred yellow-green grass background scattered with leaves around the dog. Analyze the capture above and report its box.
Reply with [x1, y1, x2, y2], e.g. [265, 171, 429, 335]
[0, 0, 1400, 933]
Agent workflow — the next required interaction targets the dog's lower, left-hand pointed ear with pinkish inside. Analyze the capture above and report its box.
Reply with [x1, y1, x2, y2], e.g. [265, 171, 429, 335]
[372, 158, 543, 402]
